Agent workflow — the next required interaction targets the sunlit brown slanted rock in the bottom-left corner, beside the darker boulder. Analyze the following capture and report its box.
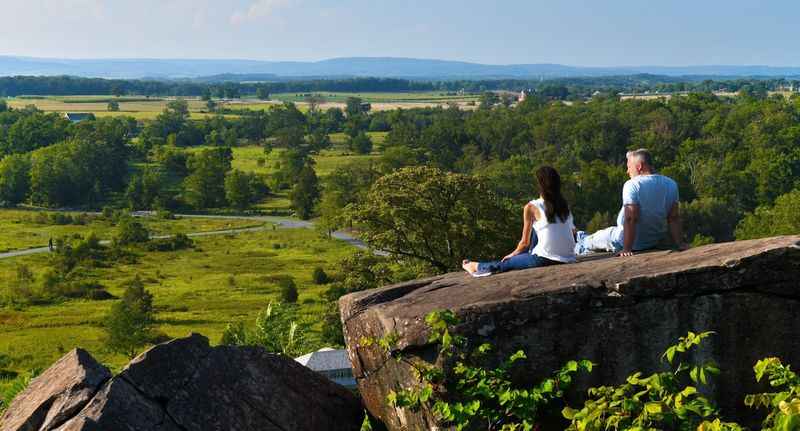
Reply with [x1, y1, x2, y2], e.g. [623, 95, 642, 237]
[0, 349, 111, 430]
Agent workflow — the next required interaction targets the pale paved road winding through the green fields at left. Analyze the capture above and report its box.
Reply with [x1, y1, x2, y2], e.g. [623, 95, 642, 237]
[0, 212, 372, 259]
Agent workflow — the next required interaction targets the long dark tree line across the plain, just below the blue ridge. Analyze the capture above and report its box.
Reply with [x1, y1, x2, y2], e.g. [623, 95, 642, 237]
[0, 74, 800, 100]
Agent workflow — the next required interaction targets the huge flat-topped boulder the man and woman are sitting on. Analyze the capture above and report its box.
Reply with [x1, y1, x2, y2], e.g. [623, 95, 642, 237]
[339, 236, 800, 429]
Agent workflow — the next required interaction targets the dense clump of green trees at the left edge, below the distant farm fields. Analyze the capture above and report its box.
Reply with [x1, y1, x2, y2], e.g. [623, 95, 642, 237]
[0, 111, 135, 207]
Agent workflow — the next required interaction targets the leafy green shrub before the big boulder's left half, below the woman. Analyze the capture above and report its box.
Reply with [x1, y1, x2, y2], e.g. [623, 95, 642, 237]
[378, 311, 593, 430]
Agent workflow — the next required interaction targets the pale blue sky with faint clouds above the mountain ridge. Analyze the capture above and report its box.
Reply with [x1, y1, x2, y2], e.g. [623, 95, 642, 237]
[0, 0, 800, 66]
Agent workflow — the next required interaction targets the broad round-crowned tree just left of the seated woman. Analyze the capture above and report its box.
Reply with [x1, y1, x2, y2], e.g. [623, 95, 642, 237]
[350, 167, 521, 272]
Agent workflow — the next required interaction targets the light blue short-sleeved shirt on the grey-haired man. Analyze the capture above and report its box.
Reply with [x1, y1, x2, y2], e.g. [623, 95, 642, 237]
[617, 174, 678, 250]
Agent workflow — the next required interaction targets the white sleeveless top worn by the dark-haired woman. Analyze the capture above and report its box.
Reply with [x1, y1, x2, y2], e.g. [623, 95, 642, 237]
[531, 198, 575, 263]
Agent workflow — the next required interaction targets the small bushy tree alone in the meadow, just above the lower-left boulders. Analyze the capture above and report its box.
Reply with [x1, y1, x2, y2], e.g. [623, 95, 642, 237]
[103, 276, 155, 359]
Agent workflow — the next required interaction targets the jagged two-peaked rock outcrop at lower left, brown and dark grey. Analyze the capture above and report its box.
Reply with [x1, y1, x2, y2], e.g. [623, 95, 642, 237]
[0, 334, 363, 431]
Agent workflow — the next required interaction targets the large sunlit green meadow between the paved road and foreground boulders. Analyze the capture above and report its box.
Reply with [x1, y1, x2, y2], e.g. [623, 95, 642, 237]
[0, 229, 352, 372]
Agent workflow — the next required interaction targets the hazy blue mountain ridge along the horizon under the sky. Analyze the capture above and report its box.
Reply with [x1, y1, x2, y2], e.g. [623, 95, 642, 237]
[0, 56, 800, 80]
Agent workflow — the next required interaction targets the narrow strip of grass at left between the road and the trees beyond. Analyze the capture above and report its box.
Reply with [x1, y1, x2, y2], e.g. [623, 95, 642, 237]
[0, 209, 261, 252]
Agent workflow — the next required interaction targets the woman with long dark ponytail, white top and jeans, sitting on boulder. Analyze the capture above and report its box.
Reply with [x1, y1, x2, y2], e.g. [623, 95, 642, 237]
[462, 166, 575, 277]
